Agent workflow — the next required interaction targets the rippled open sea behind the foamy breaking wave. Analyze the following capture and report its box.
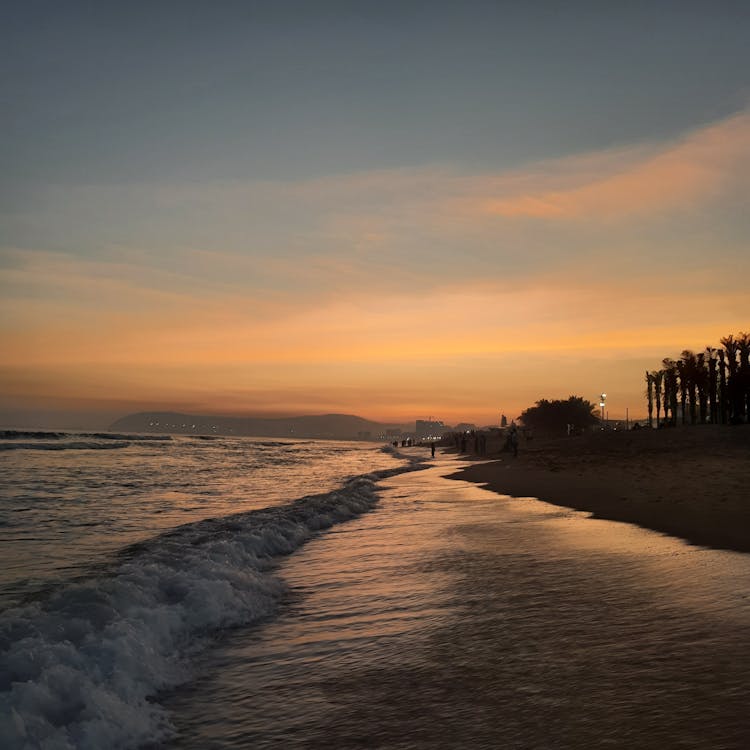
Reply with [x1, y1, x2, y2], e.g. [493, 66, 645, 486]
[0, 433, 406, 607]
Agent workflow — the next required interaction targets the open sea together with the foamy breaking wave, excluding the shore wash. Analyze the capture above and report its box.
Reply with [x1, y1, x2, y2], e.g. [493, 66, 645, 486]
[0, 431, 421, 749]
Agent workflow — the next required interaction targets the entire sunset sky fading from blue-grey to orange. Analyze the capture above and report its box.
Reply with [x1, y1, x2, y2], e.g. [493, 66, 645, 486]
[0, 0, 750, 428]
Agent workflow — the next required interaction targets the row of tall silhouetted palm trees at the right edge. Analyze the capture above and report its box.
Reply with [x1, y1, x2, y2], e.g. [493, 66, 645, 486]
[646, 332, 750, 427]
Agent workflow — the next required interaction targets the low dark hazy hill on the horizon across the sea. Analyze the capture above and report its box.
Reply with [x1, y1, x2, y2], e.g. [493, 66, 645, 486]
[109, 411, 409, 440]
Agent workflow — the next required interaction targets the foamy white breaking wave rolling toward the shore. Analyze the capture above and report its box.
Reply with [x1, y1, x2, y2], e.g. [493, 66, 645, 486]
[0, 460, 421, 750]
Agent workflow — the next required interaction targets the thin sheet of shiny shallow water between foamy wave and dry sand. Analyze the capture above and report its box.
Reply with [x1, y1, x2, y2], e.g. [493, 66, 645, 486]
[165, 459, 750, 749]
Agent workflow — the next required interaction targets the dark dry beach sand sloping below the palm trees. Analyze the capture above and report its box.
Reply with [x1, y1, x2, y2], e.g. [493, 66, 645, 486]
[452, 425, 750, 552]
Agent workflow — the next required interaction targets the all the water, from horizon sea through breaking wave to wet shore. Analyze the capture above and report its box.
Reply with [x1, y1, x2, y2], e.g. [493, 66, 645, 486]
[0, 432, 750, 750]
